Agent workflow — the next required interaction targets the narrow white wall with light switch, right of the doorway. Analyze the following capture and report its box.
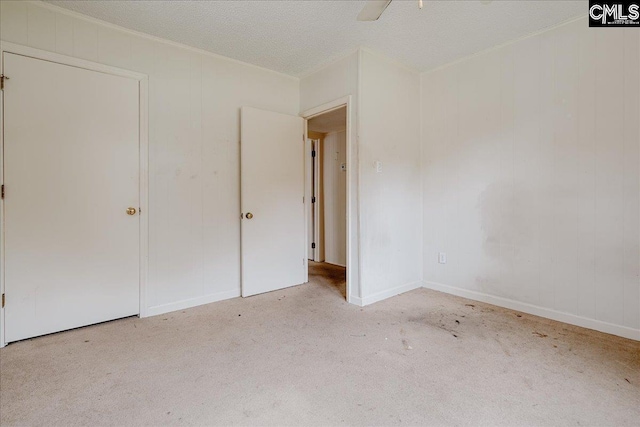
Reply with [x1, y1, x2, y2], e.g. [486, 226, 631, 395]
[359, 50, 422, 304]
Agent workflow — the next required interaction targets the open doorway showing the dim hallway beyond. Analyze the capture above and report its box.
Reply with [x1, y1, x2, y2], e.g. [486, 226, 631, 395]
[305, 105, 348, 299]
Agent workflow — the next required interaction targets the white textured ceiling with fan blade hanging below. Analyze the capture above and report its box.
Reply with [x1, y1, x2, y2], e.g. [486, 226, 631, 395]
[50, 0, 588, 76]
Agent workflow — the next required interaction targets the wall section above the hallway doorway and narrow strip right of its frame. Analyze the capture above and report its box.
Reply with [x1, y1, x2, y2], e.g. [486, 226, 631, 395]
[300, 52, 362, 304]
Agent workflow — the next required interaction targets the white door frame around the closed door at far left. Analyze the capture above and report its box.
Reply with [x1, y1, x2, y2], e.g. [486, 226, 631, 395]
[0, 41, 149, 347]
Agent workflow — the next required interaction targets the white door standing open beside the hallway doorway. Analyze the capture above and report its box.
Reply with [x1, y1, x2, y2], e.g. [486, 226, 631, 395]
[241, 107, 307, 297]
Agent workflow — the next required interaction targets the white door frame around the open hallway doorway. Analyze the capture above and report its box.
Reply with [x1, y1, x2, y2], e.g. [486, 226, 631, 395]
[301, 95, 360, 303]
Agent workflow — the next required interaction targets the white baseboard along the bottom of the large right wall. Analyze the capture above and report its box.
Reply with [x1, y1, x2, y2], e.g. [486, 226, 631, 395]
[423, 281, 640, 341]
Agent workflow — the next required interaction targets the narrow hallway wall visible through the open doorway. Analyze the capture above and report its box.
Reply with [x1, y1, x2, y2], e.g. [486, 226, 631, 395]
[321, 131, 347, 267]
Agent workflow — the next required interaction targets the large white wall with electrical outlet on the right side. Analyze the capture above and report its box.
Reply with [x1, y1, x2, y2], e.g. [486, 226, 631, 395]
[420, 19, 640, 339]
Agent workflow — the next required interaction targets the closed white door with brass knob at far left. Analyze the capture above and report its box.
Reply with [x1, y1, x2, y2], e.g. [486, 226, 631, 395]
[3, 53, 140, 342]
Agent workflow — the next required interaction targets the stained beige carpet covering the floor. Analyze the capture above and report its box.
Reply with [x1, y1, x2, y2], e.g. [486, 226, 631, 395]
[0, 265, 640, 426]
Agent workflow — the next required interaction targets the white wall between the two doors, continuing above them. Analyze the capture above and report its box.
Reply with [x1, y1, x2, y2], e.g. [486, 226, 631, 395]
[0, 1, 300, 314]
